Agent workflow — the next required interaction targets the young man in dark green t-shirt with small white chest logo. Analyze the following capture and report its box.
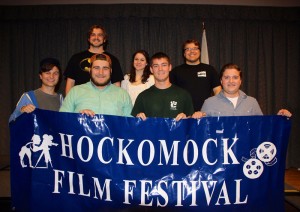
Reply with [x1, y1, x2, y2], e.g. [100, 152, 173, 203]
[131, 52, 194, 121]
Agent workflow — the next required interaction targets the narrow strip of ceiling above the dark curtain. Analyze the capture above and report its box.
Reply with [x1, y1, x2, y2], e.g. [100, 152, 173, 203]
[0, 0, 300, 7]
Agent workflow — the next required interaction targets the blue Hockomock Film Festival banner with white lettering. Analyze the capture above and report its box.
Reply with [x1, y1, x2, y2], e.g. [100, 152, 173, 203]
[10, 109, 291, 212]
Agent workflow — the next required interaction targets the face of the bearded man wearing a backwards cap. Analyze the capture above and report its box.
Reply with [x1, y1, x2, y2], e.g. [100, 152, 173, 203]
[90, 60, 111, 89]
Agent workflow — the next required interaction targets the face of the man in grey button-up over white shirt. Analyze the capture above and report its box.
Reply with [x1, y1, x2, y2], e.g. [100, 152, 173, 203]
[221, 68, 242, 97]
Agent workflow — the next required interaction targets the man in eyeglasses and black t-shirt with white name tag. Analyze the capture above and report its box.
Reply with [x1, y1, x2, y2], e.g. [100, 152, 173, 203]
[170, 40, 222, 111]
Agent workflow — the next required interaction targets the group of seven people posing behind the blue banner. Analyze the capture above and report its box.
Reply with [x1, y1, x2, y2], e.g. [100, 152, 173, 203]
[9, 25, 292, 121]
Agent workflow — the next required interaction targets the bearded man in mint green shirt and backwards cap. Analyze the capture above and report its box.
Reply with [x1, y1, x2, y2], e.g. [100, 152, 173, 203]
[60, 54, 132, 116]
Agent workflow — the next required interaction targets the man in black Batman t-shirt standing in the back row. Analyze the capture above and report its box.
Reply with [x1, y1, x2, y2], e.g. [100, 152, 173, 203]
[64, 25, 124, 95]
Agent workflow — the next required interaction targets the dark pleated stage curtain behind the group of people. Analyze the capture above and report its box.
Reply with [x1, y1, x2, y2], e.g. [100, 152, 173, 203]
[0, 4, 300, 167]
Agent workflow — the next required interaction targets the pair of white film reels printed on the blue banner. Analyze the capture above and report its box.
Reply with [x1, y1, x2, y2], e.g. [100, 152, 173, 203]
[242, 141, 277, 179]
